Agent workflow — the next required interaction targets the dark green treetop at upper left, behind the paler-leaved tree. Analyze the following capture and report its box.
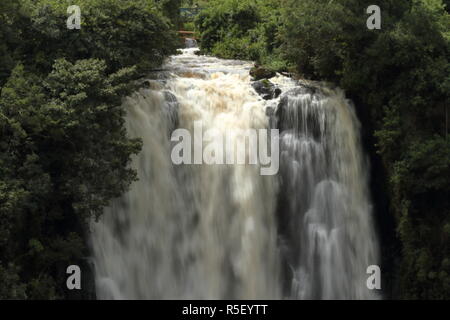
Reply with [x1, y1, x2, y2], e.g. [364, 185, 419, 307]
[20, 0, 178, 73]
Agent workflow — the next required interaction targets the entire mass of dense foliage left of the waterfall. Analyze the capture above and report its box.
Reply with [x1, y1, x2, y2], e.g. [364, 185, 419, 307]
[0, 0, 177, 299]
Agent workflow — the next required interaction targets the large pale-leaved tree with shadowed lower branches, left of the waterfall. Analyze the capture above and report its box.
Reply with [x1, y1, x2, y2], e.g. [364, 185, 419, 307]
[0, 59, 140, 299]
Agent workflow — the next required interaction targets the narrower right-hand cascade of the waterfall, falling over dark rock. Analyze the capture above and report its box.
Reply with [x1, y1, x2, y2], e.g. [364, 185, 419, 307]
[274, 86, 378, 299]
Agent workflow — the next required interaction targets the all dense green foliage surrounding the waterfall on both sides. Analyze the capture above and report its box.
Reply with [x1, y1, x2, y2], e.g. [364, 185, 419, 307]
[0, 0, 450, 299]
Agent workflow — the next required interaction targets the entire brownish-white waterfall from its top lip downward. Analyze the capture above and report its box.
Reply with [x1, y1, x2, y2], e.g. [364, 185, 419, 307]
[92, 49, 378, 299]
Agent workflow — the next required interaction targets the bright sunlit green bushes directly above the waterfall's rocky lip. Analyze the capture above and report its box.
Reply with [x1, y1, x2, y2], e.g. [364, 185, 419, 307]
[196, 0, 286, 70]
